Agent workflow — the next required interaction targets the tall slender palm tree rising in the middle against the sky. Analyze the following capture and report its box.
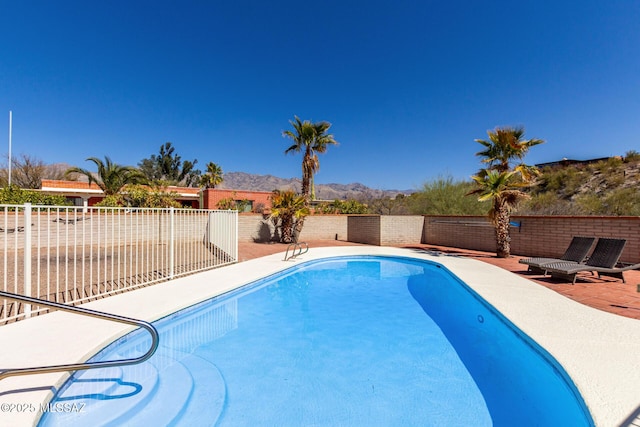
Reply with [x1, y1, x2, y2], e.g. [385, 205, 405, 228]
[282, 116, 338, 201]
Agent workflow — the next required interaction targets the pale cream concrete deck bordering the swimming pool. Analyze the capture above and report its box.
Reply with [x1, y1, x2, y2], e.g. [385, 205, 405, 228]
[0, 245, 640, 426]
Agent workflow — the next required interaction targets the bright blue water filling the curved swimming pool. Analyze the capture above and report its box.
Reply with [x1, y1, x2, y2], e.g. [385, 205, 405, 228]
[41, 257, 593, 426]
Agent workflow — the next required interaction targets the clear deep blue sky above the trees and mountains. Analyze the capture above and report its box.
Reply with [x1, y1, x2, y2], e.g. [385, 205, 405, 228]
[0, 0, 640, 189]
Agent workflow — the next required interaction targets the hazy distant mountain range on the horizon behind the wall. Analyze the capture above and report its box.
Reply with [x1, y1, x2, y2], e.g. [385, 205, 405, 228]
[219, 172, 414, 200]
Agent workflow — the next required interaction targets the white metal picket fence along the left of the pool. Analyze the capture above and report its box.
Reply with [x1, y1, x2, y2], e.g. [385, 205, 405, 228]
[0, 204, 238, 323]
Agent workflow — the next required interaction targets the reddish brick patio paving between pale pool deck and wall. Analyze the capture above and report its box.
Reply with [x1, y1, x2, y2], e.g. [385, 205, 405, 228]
[238, 240, 640, 319]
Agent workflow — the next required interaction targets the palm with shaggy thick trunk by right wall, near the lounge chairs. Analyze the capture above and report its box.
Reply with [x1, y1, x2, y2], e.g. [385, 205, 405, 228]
[467, 127, 544, 258]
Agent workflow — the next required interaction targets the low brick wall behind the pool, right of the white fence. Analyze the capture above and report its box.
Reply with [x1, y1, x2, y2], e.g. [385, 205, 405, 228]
[239, 214, 640, 263]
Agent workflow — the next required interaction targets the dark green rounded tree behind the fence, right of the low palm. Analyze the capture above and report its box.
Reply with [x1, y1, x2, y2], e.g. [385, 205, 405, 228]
[138, 142, 201, 187]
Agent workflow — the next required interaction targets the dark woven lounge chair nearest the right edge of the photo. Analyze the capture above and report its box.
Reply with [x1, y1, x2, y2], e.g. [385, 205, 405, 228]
[543, 238, 640, 284]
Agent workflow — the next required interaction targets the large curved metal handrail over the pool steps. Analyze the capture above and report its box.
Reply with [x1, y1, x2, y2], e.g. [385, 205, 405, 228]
[0, 291, 160, 380]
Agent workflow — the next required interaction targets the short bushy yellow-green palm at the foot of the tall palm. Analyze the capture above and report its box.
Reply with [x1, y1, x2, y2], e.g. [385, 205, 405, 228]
[271, 190, 309, 243]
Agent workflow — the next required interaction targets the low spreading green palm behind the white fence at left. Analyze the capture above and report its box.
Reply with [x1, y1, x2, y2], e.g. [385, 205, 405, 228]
[65, 156, 146, 196]
